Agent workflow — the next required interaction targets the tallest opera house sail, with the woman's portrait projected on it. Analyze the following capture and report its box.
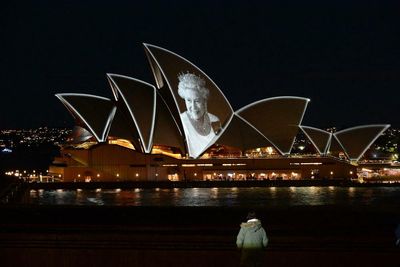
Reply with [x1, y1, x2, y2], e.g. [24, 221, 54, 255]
[144, 44, 233, 158]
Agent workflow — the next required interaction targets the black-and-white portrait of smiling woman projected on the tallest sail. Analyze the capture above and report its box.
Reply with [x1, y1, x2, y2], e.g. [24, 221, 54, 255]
[178, 73, 221, 157]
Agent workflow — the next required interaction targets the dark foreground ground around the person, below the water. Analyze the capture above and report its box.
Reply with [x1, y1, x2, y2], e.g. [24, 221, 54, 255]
[0, 204, 400, 267]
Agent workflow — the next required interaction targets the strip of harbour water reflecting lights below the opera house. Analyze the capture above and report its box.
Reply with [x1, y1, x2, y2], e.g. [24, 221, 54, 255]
[29, 186, 400, 207]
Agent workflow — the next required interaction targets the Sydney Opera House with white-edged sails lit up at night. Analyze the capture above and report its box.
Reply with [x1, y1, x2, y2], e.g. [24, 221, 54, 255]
[49, 44, 389, 181]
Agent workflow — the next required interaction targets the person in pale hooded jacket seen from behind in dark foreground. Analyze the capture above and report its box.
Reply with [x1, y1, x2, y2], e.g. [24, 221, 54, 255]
[236, 211, 268, 266]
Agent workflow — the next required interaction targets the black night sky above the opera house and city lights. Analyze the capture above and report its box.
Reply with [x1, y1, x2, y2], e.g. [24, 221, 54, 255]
[0, 0, 400, 129]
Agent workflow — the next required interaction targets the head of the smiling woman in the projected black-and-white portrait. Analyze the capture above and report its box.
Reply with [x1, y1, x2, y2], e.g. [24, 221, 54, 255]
[178, 73, 210, 120]
